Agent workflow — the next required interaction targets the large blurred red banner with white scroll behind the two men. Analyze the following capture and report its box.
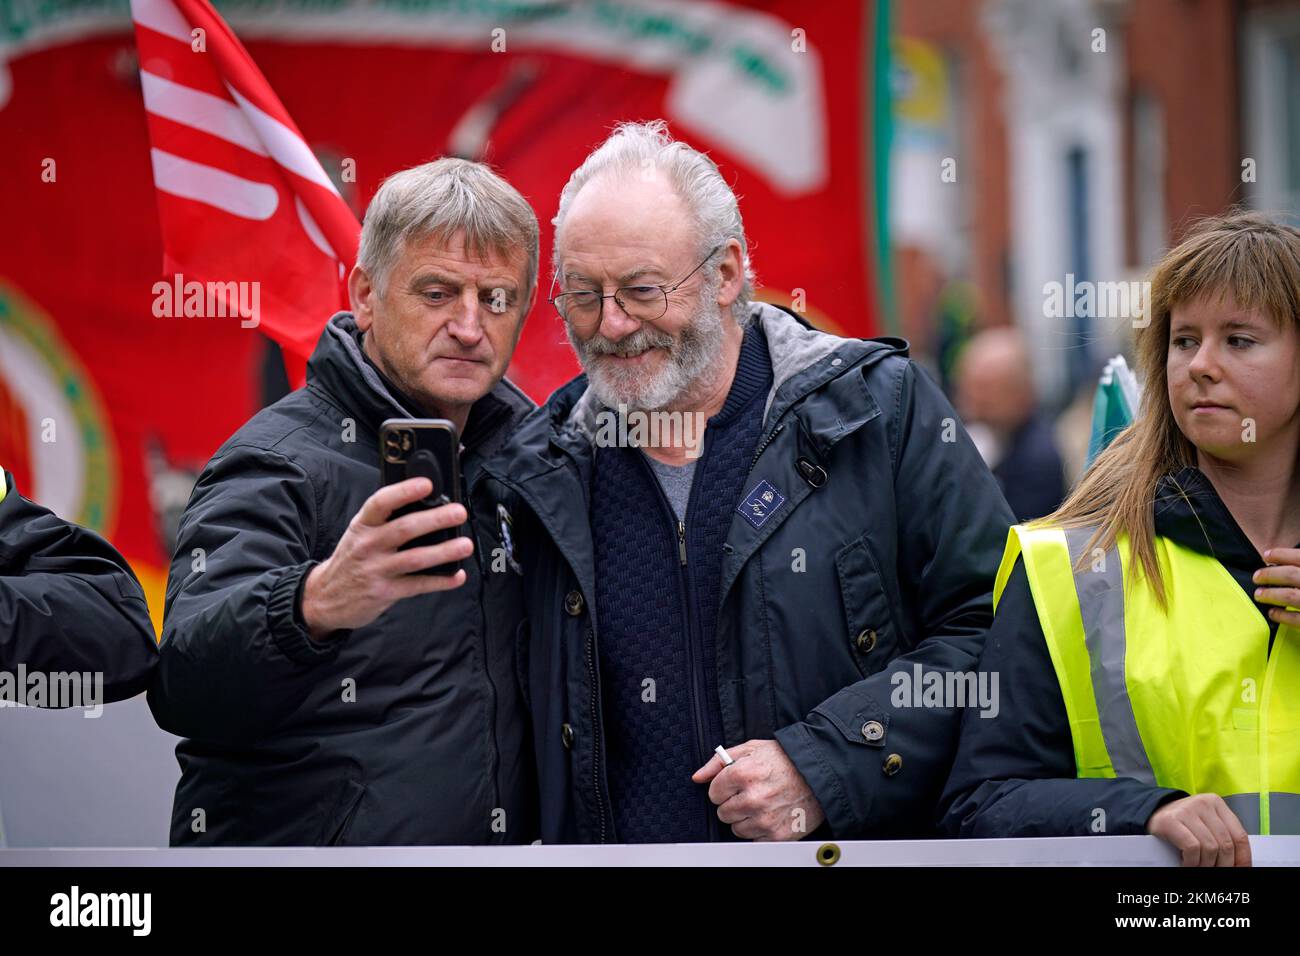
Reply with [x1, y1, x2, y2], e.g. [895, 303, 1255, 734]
[0, 0, 884, 620]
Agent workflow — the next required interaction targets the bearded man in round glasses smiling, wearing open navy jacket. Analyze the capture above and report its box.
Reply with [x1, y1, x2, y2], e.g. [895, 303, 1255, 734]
[488, 122, 1013, 843]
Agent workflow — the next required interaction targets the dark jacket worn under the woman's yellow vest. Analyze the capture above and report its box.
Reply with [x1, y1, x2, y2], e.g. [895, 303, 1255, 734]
[940, 468, 1277, 838]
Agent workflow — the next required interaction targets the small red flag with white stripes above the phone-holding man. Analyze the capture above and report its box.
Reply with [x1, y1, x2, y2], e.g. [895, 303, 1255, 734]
[131, 0, 360, 385]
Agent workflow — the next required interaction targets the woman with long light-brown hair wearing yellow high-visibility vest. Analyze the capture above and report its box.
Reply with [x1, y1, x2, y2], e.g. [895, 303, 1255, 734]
[940, 212, 1300, 865]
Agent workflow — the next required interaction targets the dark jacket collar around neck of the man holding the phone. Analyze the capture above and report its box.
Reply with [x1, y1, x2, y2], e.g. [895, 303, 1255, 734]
[307, 312, 534, 454]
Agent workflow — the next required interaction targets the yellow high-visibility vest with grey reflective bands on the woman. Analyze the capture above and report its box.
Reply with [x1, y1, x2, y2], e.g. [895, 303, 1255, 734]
[993, 524, 1300, 834]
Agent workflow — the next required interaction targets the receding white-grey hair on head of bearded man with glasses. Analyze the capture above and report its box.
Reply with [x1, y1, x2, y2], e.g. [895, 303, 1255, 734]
[551, 120, 754, 325]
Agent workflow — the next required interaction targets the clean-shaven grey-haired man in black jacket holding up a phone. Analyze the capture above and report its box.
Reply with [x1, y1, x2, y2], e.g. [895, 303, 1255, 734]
[150, 159, 538, 845]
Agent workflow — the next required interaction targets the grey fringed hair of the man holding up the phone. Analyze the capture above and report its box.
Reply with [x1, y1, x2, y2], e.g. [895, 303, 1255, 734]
[356, 157, 540, 303]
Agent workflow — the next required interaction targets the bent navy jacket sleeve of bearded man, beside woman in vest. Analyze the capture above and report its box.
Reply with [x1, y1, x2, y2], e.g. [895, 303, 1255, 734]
[776, 362, 1014, 839]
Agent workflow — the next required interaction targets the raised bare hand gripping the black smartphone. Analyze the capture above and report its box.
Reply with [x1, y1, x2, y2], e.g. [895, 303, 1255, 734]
[303, 477, 475, 640]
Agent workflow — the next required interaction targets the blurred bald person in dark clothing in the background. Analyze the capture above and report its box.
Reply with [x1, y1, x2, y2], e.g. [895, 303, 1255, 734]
[957, 328, 1066, 522]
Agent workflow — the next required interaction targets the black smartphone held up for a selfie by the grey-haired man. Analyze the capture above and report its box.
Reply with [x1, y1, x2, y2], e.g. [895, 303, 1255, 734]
[380, 419, 460, 575]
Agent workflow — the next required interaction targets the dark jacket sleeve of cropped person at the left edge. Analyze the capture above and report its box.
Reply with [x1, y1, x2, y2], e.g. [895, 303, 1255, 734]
[0, 472, 159, 702]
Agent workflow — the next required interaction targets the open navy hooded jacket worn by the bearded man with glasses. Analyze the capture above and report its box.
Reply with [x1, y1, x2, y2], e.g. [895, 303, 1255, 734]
[489, 304, 1011, 843]
